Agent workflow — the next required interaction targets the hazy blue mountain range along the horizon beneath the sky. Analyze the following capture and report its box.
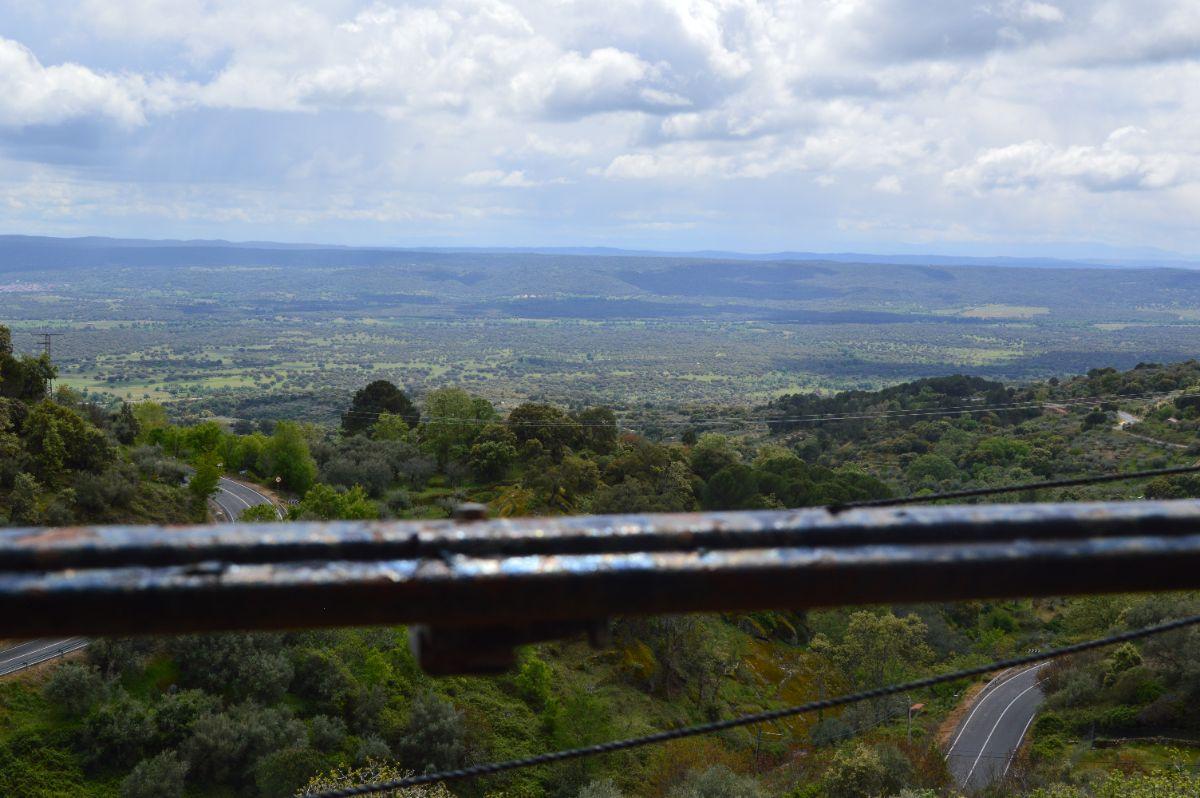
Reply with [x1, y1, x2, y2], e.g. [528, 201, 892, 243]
[0, 235, 1200, 271]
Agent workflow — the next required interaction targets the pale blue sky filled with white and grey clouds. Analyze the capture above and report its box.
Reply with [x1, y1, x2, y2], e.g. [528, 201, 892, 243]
[0, 0, 1200, 256]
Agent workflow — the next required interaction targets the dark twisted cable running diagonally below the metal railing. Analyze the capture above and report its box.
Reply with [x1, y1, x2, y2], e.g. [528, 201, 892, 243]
[308, 616, 1200, 798]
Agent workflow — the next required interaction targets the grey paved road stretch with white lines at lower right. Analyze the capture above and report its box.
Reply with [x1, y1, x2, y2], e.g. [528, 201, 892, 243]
[946, 664, 1045, 792]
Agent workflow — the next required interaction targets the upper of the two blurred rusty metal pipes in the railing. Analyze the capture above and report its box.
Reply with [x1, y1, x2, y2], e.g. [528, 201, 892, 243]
[0, 500, 1200, 572]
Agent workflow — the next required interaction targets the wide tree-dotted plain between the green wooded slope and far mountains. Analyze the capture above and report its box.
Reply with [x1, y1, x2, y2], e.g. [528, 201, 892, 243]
[0, 244, 1200, 420]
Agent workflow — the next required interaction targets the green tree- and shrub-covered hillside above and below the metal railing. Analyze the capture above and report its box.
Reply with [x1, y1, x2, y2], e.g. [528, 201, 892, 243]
[0, 328, 1200, 798]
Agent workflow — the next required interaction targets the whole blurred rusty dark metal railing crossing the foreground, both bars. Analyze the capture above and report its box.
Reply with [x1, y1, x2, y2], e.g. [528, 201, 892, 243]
[0, 500, 1200, 672]
